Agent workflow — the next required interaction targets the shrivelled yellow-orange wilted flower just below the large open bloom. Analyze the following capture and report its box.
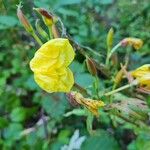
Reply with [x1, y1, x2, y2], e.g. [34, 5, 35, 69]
[70, 92, 105, 116]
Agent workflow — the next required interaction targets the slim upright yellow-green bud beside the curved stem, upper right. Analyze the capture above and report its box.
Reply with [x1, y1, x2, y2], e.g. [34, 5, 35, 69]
[107, 28, 114, 49]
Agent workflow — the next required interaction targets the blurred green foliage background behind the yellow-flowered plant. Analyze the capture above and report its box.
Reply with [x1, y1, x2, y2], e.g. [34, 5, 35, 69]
[0, 0, 150, 150]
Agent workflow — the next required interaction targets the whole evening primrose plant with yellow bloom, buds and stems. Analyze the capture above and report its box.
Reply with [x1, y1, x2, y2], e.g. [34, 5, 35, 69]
[17, 5, 150, 134]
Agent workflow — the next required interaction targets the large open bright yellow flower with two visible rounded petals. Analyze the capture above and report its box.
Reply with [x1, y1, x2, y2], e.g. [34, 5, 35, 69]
[30, 38, 75, 93]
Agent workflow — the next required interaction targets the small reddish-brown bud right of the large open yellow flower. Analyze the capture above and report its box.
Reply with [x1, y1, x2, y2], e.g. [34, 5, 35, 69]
[86, 57, 97, 76]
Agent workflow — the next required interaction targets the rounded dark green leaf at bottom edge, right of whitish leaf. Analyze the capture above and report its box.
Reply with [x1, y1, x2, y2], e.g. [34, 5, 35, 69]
[81, 130, 119, 150]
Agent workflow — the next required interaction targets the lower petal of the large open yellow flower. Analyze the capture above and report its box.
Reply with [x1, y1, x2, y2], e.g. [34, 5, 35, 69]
[34, 68, 74, 93]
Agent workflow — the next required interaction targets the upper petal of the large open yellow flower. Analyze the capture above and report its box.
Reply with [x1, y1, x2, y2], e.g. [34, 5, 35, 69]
[30, 38, 75, 72]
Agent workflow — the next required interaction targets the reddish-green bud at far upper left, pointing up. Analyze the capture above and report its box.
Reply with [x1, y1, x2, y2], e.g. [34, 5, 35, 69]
[17, 4, 33, 33]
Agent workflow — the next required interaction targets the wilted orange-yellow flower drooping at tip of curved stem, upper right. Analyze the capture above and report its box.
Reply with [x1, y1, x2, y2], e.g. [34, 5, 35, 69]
[121, 37, 143, 50]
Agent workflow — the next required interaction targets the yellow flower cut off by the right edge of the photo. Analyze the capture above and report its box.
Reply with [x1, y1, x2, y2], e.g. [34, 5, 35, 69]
[131, 64, 150, 87]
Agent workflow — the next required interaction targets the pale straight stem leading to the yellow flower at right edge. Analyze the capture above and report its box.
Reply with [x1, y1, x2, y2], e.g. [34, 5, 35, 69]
[104, 80, 138, 96]
